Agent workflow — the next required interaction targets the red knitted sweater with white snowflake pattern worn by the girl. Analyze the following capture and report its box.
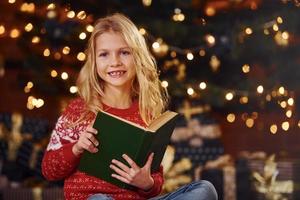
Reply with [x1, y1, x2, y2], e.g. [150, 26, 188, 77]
[42, 98, 163, 200]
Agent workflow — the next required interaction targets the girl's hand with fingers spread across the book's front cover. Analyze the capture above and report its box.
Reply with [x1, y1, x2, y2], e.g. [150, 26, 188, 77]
[110, 153, 154, 190]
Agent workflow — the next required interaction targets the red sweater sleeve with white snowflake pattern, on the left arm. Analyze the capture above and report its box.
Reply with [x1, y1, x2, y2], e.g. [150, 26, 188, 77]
[42, 100, 89, 180]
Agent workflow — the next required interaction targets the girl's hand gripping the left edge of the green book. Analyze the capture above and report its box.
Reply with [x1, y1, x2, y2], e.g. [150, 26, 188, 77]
[72, 126, 99, 156]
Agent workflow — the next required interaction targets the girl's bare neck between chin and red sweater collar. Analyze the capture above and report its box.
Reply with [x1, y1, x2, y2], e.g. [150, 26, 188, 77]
[101, 85, 132, 109]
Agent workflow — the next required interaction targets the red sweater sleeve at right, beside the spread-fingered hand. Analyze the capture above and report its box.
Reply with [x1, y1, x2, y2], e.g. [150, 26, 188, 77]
[137, 166, 164, 199]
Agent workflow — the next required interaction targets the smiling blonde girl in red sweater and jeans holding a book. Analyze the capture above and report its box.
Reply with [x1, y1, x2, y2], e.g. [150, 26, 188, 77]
[42, 14, 217, 200]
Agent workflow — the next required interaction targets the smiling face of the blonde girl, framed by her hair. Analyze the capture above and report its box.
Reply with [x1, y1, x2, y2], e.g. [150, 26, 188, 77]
[95, 32, 136, 90]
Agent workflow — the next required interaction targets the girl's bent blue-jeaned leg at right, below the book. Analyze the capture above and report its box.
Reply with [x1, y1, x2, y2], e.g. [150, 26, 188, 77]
[151, 180, 218, 200]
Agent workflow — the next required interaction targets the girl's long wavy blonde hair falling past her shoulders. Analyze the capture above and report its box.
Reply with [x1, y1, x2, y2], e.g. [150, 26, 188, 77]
[77, 13, 168, 124]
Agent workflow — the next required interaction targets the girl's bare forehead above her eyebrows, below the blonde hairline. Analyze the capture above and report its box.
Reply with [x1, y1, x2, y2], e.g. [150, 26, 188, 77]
[95, 31, 129, 50]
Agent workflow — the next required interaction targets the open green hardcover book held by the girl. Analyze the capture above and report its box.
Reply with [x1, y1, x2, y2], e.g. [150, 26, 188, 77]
[78, 111, 179, 189]
